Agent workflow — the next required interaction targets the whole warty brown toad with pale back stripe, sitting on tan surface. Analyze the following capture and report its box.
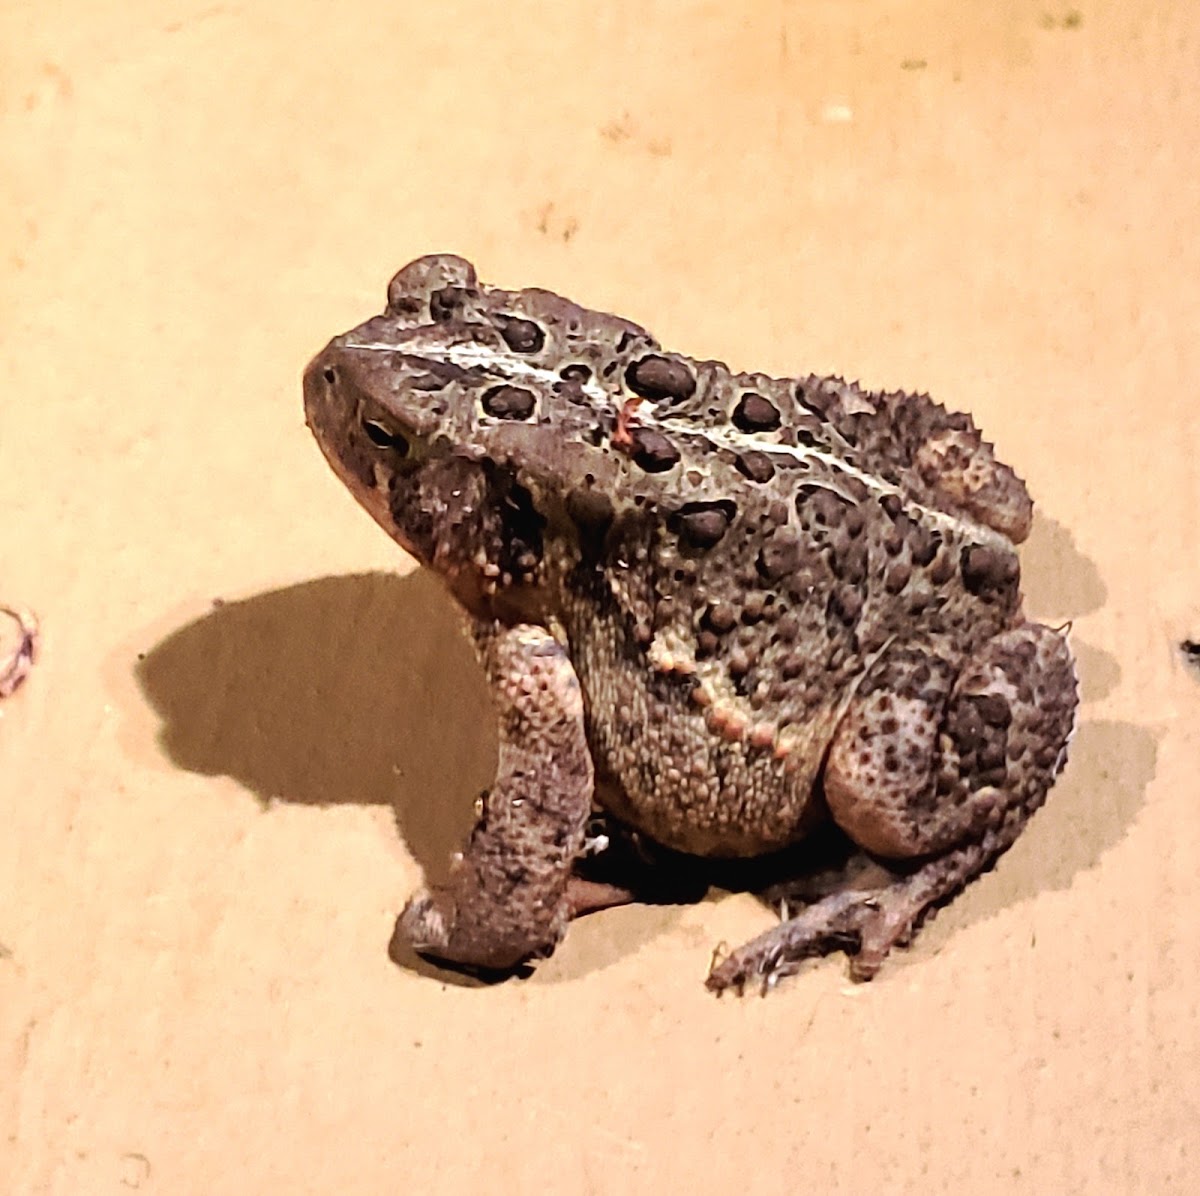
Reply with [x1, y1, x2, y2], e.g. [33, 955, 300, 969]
[305, 256, 1076, 991]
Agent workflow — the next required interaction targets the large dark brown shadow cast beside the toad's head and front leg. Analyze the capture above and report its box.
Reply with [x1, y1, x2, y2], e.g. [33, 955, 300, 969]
[136, 571, 691, 984]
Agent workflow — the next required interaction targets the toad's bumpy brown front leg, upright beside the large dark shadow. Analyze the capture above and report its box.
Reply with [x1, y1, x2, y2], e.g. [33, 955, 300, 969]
[398, 621, 597, 969]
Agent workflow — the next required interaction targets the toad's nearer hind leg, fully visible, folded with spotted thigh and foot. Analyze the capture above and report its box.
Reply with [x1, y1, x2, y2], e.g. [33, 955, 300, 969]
[708, 624, 1078, 992]
